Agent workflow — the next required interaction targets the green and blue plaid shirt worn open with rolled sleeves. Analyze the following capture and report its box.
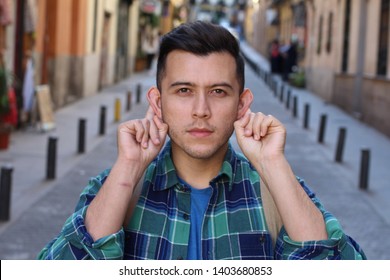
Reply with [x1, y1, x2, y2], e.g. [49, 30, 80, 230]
[38, 143, 366, 260]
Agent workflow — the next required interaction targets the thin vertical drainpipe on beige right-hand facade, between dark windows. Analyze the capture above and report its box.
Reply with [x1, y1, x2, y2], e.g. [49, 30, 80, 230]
[352, 0, 367, 119]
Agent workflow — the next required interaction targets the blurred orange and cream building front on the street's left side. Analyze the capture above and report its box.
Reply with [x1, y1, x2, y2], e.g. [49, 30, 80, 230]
[35, 0, 139, 107]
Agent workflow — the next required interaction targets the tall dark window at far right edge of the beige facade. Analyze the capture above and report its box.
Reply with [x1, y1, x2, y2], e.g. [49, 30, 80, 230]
[377, 0, 390, 76]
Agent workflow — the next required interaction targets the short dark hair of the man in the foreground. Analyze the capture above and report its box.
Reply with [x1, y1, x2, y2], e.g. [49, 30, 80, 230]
[156, 21, 245, 93]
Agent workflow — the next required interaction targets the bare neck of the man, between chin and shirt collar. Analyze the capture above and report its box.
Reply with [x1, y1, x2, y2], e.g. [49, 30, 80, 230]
[172, 143, 228, 189]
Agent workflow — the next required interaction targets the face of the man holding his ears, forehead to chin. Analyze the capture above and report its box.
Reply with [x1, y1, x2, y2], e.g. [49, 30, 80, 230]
[160, 51, 244, 159]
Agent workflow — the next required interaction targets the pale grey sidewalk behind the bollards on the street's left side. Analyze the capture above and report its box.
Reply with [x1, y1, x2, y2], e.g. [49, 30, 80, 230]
[0, 73, 154, 234]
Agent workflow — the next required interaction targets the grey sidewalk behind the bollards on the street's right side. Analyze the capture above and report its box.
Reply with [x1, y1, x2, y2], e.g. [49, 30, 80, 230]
[241, 42, 390, 224]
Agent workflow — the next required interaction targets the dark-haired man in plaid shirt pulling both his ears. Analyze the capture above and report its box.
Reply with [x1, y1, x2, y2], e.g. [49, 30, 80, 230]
[39, 22, 365, 259]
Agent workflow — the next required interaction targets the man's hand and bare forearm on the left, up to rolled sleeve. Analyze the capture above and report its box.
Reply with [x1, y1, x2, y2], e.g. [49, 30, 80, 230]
[85, 107, 168, 240]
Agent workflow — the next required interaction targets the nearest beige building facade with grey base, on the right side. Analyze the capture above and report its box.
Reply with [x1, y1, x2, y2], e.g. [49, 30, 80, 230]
[306, 0, 390, 136]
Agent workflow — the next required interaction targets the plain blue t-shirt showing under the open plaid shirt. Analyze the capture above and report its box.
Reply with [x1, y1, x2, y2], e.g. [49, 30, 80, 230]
[179, 179, 212, 260]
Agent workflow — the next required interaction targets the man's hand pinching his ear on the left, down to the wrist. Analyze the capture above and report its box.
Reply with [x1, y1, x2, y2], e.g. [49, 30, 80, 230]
[118, 107, 168, 169]
